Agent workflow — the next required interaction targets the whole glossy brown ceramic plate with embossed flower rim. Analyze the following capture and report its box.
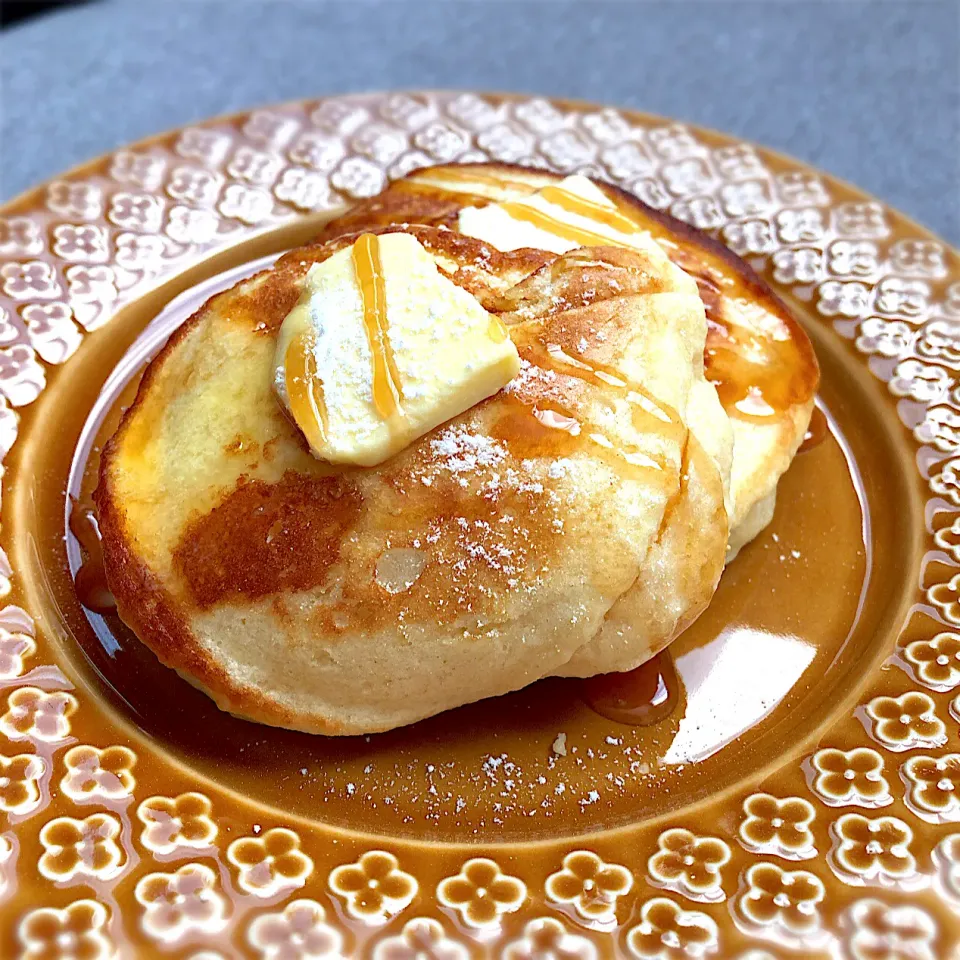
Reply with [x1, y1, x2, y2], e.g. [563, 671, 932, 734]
[0, 93, 960, 960]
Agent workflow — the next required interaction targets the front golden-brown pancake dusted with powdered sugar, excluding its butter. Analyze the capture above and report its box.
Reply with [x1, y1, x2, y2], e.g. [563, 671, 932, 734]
[95, 225, 730, 735]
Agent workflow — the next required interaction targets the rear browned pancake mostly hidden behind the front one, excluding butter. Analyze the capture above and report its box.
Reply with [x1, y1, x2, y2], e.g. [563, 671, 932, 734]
[320, 163, 819, 561]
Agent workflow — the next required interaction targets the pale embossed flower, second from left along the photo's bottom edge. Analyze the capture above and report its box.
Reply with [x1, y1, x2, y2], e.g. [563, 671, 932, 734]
[134, 863, 227, 943]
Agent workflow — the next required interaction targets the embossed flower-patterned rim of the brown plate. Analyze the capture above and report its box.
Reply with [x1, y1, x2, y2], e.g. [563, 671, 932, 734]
[0, 93, 960, 960]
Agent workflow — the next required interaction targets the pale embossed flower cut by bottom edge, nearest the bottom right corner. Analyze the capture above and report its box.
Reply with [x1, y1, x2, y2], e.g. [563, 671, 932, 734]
[841, 899, 937, 960]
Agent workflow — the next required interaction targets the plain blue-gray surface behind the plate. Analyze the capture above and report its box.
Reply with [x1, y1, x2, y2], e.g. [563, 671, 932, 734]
[0, 0, 960, 244]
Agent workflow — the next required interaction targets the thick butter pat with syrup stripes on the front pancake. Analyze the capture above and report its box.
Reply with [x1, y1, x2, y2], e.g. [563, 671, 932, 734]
[274, 233, 520, 466]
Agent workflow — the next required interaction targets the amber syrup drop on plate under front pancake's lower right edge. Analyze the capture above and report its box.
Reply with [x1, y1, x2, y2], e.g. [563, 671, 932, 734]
[583, 650, 680, 727]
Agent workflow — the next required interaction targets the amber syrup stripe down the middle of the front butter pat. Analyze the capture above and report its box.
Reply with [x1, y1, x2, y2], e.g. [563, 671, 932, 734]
[353, 233, 403, 421]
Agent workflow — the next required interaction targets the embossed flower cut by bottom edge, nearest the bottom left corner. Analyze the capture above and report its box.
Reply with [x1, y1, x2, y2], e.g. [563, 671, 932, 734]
[18, 900, 116, 960]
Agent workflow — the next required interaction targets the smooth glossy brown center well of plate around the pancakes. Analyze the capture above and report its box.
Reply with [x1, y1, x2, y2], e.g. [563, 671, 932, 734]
[11, 224, 917, 841]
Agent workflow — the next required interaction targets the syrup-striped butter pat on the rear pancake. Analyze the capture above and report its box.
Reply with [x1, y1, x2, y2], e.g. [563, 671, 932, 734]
[458, 176, 660, 256]
